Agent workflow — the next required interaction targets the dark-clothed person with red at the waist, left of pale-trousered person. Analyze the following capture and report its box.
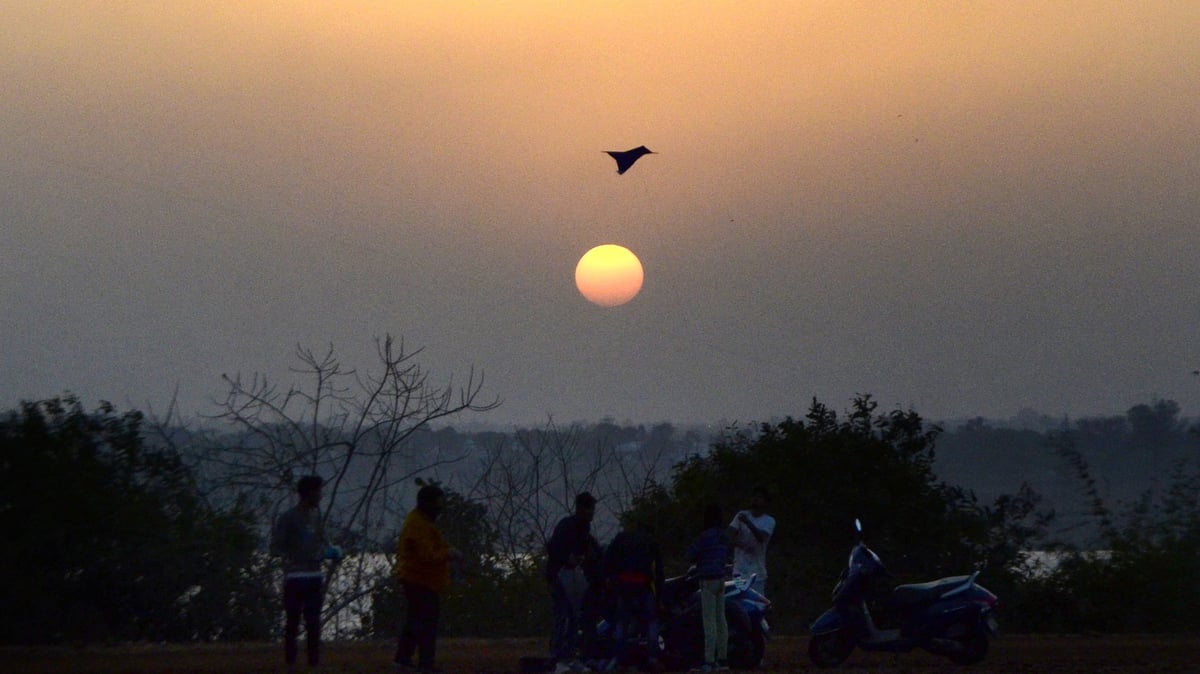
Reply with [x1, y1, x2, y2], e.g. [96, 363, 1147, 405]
[604, 518, 664, 672]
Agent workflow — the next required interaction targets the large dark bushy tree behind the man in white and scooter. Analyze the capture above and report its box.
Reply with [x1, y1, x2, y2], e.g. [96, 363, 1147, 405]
[628, 396, 1030, 628]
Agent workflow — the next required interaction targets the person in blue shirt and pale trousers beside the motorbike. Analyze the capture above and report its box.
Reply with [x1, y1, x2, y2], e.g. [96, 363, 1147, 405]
[688, 504, 730, 672]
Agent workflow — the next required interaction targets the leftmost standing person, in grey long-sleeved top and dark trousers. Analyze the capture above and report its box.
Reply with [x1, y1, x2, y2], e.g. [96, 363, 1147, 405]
[271, 475, 342, 670]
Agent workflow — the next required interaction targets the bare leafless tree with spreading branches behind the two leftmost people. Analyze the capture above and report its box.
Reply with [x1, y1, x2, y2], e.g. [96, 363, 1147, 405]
[160, 336, 500, 633]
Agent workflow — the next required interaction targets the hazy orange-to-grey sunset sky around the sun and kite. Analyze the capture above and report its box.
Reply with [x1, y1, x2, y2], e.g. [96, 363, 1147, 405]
[0, 0, 1200, 423]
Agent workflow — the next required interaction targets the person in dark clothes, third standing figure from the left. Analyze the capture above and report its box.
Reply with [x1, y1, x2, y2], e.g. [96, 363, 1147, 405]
[546, 492, 596, 672]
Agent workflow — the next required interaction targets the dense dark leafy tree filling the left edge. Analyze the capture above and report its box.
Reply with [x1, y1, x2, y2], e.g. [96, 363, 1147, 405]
[0, 396, 267, 643]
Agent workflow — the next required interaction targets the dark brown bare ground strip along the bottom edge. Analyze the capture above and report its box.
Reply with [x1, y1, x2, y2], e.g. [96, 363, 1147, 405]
[0, 636, 1200, 674]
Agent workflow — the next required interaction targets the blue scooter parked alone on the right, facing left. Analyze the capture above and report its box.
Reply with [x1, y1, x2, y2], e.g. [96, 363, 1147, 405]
[809, 519, 998, 667]
